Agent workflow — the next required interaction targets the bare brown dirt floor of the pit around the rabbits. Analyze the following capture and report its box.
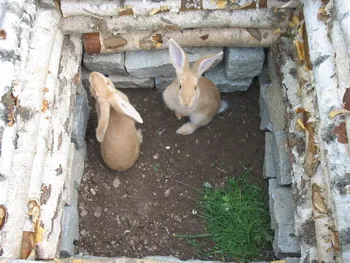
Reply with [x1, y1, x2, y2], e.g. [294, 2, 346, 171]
[76, 83, 265, 260]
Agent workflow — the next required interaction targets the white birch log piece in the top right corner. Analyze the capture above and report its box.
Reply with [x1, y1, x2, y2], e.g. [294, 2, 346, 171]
[334, 0, 350, 57]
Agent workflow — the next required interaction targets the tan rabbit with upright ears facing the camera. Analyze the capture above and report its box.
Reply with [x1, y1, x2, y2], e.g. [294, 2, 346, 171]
[163, 39, 227, 135]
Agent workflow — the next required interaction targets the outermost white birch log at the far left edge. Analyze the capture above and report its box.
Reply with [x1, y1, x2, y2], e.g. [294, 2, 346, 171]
[0, 0, 36, 231]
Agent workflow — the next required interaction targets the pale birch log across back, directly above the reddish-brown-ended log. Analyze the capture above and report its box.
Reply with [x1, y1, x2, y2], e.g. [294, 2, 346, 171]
[60, 9, 291, 34]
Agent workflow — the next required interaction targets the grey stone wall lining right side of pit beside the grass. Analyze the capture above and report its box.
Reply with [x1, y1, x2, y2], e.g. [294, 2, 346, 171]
[259, 66, 301, 258]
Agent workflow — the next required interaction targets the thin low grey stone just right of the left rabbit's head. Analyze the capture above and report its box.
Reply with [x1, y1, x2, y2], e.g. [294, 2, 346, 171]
[108, 75, 154, 89]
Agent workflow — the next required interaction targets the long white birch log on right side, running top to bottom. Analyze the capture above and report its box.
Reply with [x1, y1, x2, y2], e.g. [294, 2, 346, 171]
[303, 0, 350, 262]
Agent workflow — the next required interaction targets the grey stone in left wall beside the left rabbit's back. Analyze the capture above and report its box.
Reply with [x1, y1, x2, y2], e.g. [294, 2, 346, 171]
[72, 94, 90, 149]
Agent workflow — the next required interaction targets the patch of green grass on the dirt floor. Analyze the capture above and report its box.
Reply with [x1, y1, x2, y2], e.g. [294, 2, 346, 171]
[181, 169, 272, 262]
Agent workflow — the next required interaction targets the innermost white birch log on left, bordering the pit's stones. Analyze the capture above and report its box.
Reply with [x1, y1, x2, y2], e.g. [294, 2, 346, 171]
[38, 35, 82, 259]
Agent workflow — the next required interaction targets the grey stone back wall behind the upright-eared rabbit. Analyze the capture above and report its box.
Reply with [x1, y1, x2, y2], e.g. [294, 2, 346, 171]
[83, 47, 265, 92]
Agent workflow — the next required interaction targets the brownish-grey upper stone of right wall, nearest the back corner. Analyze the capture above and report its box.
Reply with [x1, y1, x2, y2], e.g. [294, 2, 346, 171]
[265, 81, 286, 132]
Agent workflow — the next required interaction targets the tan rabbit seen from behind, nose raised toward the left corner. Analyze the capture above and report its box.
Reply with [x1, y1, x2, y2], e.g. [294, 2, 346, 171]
[89, 71, 143, 171]
